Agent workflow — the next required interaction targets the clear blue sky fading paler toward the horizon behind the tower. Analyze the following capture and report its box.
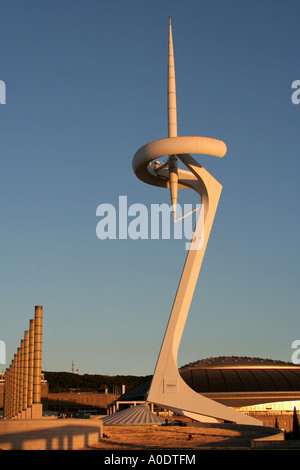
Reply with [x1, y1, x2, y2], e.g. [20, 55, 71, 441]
[0, 0, 300, 375]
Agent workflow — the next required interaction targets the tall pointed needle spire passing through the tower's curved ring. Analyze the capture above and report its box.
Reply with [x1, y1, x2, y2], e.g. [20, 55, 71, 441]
[168, 16, 178, 221]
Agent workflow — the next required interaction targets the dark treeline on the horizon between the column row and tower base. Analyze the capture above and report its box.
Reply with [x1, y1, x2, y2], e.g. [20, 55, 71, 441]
[43, 372, 151, 393]
